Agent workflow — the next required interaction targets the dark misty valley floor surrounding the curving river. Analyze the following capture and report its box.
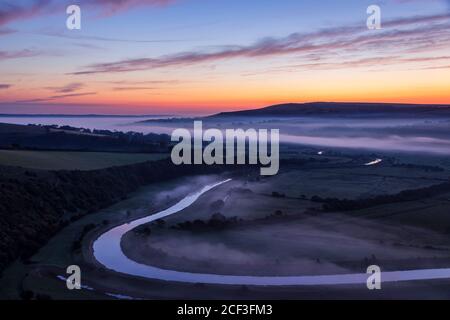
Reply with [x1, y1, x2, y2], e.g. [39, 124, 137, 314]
[0, 149, 450, 299]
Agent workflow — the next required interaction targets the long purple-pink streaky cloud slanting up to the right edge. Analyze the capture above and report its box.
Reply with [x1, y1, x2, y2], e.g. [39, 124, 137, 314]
[73, 14, 450, 75]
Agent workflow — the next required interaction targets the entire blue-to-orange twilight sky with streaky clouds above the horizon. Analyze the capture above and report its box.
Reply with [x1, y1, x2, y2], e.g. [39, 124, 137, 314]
[0, 0, 450, 115]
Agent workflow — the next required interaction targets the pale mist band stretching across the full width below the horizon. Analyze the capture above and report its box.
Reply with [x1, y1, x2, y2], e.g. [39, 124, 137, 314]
[0, 107, 450, 155]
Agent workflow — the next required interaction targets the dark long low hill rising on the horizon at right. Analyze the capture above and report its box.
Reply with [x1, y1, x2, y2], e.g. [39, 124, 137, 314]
[212, 102, 450, 118]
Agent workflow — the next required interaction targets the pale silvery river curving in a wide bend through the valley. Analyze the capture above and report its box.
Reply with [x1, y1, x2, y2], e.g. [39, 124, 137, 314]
[93, 179, 450, 286]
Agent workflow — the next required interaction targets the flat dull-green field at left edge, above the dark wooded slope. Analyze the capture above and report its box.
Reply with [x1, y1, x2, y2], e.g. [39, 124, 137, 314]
[0, 150, 168, 170]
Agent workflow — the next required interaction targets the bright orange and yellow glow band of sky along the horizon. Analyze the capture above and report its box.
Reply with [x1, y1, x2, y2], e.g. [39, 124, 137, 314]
[0, 65, 450, 114]
